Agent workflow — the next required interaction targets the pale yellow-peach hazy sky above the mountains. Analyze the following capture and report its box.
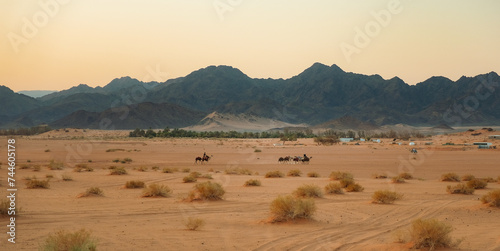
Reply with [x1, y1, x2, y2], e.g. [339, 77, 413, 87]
[0, 0, 500, 91]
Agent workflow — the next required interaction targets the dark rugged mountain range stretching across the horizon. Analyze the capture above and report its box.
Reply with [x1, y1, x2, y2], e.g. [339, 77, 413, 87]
[0, 63, 500, 130]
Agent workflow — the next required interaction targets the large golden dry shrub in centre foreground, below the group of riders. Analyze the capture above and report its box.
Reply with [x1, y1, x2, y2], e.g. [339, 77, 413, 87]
[270, 195, 316, 222]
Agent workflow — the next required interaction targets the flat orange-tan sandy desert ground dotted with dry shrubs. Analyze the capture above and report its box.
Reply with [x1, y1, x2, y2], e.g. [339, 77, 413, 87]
[0, 131, 500, 250]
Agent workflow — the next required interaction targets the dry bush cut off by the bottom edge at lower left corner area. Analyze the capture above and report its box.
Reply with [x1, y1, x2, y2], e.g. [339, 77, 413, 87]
[40, 229, 97, 251]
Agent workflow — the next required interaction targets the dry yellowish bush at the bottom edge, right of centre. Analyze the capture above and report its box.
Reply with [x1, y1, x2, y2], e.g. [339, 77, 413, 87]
[410, 219, 453, 250]
